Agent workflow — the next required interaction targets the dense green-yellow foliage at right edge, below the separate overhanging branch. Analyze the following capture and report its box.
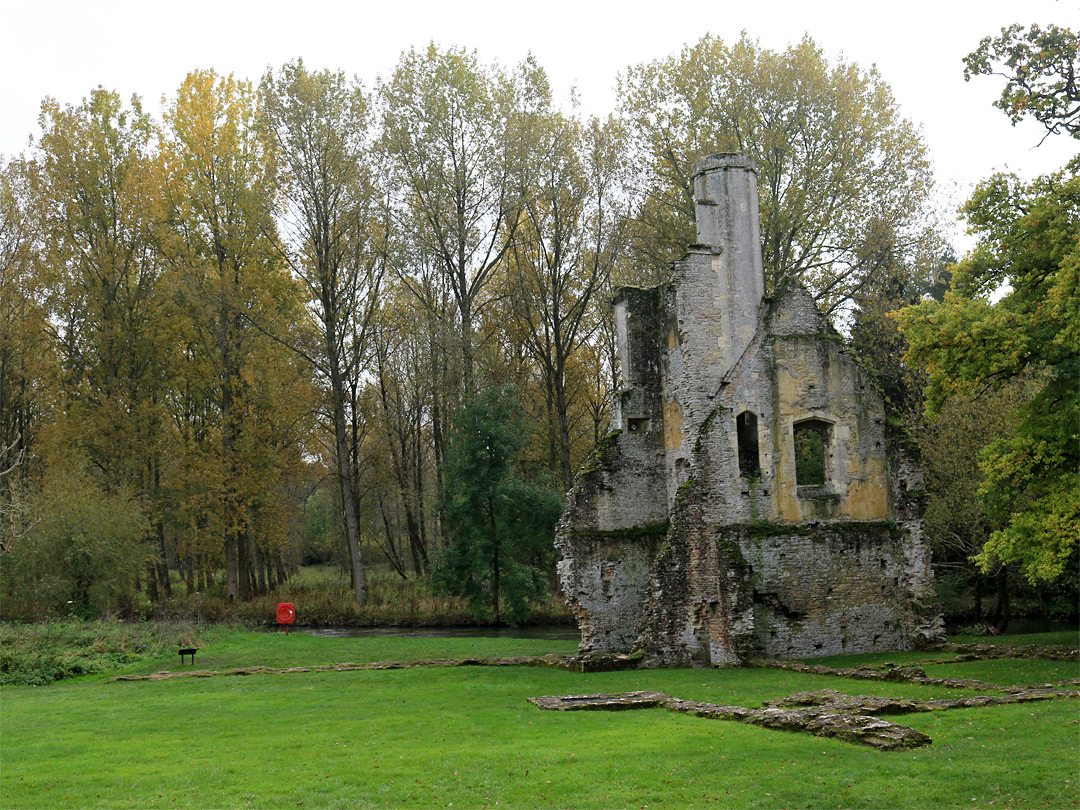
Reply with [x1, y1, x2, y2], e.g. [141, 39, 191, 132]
[900, 161, 1080, 582]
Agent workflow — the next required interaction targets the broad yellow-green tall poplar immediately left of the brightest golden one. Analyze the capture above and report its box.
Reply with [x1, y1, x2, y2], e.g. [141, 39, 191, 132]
[33, 87, 170, 596]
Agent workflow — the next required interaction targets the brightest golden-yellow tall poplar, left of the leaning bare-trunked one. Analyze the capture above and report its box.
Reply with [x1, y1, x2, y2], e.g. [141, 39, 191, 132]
[164, 70, 293, 598]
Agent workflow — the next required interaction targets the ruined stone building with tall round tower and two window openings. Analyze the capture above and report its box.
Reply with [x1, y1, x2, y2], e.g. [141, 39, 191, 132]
[555, 154, 945, 665]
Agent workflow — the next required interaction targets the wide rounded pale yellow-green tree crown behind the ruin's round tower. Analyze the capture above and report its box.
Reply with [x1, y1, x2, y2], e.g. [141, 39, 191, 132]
[620, 36, 932, 310]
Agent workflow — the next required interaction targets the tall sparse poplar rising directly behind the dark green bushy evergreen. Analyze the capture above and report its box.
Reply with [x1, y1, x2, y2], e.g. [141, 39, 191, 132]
[380, 44, 540, 395]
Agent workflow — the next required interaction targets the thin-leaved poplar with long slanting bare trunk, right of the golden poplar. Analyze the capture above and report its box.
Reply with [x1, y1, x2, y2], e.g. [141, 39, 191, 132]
[262, 62, 387, 603]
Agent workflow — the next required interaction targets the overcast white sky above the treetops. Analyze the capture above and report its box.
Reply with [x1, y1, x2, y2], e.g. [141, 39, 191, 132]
[0, 0, 1080, 228]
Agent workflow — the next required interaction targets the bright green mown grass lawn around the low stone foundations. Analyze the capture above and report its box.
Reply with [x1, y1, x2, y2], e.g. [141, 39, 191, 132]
[0, 631, 1080, 810]
